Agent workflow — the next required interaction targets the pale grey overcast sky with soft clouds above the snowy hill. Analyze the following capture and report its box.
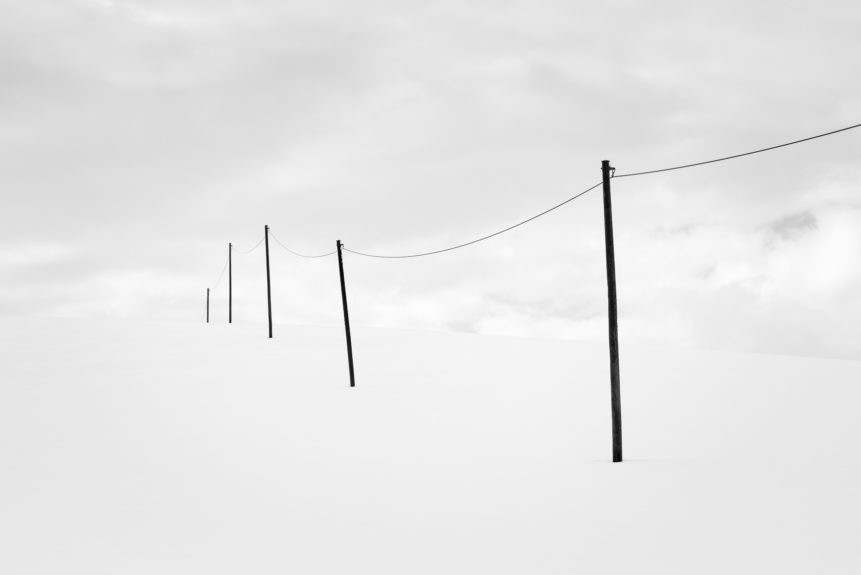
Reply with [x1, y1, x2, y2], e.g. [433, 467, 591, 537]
[0, 0, 861, 359]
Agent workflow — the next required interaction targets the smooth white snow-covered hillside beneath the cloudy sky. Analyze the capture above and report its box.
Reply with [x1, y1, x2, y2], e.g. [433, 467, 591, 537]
[0, 318, 861, 575]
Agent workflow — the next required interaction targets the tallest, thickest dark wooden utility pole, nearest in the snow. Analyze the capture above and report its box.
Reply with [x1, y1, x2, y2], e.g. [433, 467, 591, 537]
[601, 160, 622, 462]
